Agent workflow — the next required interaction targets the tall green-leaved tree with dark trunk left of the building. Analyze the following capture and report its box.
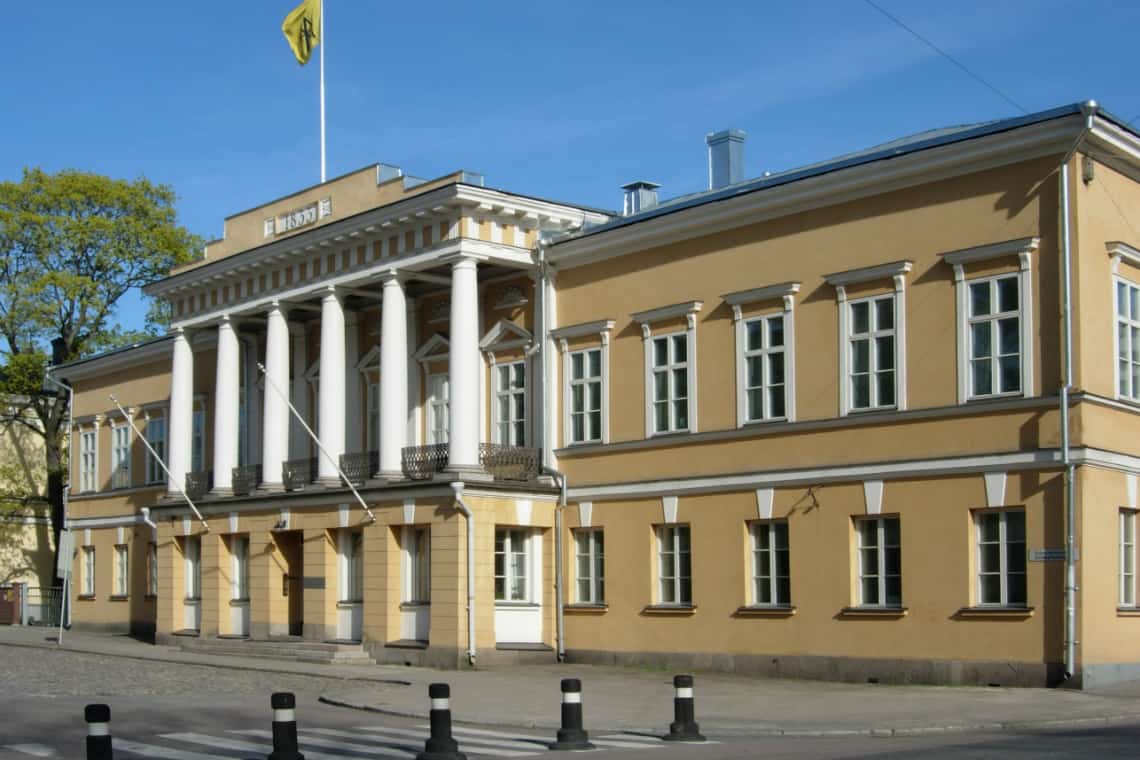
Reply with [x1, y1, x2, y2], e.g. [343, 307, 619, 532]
[0, 169, 201, 576]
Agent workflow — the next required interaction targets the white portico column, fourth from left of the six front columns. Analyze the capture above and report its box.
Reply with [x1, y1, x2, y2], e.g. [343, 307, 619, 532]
[317, 287, 344, 483]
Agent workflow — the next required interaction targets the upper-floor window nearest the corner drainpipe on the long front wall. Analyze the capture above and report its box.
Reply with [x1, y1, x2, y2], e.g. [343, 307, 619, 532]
[968, 275, 1021, 399]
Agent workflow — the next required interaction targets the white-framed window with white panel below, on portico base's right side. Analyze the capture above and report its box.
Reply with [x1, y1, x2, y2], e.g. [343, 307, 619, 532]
[495, 528, 543, 644]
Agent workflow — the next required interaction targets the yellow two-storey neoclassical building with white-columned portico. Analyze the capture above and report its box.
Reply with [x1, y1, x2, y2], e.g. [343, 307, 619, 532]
[57, 104, 1140, 686]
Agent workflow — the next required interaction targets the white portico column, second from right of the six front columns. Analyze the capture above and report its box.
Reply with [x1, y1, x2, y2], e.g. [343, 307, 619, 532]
[380, 272, 408, 479]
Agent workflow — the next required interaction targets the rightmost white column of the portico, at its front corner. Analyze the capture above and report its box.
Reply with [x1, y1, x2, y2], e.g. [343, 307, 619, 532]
[447, 256, 482, 472]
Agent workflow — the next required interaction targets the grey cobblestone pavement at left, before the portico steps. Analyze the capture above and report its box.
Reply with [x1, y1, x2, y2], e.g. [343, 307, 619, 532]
[0, 646, 353, 698]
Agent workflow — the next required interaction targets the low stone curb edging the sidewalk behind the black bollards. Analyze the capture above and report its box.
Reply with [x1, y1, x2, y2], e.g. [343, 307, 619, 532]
[317, 694, 1140, 738]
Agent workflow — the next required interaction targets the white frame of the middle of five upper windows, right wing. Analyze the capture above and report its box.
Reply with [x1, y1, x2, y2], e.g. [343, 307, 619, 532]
[720, 283, 800, 427]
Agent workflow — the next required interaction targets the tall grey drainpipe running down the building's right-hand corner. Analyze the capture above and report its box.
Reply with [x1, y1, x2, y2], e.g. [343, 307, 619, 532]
[1060, 100, 1097, 680]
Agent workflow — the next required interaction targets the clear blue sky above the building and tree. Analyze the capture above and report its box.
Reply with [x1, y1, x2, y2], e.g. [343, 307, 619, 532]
[8, 0, 1140, 327]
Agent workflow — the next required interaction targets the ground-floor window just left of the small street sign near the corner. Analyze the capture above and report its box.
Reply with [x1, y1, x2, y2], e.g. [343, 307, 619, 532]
[974, 510, 1026, 607]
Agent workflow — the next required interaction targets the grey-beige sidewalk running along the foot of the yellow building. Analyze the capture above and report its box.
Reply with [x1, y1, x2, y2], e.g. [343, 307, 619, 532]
[0, 627, 1140, 738]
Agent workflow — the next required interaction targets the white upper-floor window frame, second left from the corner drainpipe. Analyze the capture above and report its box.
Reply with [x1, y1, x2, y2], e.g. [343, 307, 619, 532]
[823, 261, 914, 417]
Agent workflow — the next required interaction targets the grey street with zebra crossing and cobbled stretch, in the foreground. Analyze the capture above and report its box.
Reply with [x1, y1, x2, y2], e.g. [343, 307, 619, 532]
[0, 645, 1140, 760]
